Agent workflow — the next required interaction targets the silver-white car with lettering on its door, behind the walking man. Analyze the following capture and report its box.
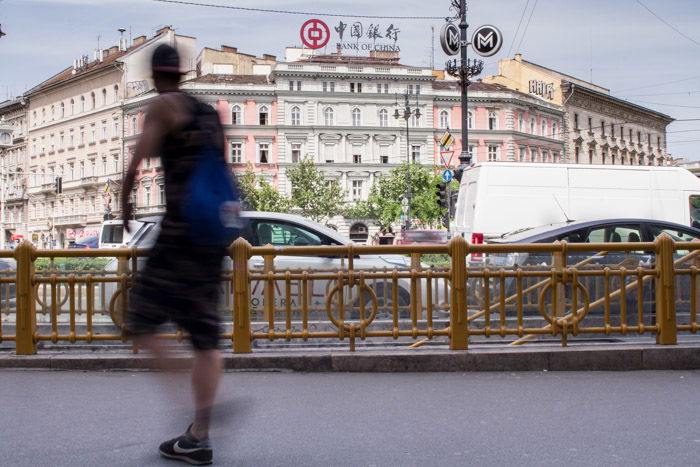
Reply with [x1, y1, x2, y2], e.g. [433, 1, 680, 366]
[106, 211, 444, 318]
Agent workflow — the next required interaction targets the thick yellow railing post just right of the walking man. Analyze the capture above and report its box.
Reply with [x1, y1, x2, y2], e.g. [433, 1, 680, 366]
[233, 237, 252, 353]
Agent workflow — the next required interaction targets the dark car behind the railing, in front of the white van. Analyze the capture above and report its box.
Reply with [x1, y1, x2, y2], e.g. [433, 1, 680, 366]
[470, 218, 700, 321]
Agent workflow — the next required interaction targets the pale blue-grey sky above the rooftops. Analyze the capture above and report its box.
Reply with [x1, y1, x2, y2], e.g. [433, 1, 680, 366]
[0, 0, 700, 160]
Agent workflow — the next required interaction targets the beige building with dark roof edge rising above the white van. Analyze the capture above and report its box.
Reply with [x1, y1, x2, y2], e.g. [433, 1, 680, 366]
[483, 54, 673, 165]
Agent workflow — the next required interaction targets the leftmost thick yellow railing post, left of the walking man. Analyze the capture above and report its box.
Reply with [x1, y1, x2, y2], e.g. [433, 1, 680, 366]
[15, 241, 36, 355]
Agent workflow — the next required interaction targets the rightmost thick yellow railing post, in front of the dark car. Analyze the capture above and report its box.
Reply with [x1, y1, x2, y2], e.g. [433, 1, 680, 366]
[654, 233, 678, 345]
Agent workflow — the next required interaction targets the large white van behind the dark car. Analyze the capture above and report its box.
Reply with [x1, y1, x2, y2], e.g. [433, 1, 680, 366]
[452, 162, 700, 247]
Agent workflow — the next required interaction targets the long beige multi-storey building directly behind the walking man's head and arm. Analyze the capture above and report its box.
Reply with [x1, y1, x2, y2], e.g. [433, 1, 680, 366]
[25, 27, 196, 248]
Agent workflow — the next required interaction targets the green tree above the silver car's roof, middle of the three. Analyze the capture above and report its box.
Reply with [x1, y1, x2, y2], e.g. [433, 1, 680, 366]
[287, 156, 345, 222]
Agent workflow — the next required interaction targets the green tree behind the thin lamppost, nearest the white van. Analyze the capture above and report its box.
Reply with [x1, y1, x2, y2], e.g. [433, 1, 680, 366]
[353, 163, 445, 230]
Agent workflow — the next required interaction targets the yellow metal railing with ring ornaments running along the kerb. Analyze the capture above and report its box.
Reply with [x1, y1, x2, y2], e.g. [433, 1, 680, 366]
[0, 235, 700, 355]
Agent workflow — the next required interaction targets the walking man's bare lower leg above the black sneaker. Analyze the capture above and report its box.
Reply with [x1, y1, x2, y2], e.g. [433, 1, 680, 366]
[190, 349, 222, 440]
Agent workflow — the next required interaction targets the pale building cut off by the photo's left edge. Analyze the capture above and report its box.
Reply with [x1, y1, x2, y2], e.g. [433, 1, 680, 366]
[0, 97, 27, 249]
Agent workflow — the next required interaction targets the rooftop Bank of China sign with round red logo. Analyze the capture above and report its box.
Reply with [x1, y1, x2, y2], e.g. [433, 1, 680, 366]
[299, 19, 401, 52]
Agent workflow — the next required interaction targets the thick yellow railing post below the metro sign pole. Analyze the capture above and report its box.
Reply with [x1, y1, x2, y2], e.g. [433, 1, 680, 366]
[447, 235, 469, 350]
